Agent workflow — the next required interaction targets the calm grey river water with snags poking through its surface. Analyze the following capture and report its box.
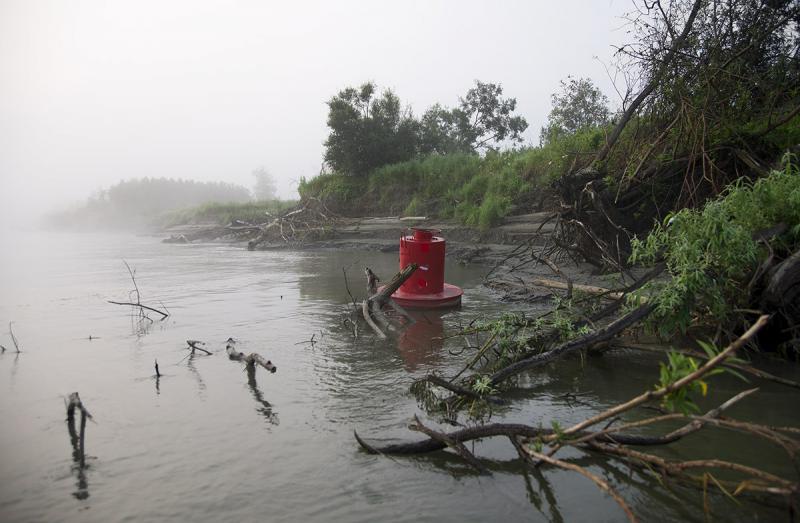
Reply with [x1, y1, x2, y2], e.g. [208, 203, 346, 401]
[0, 233, 800, 522]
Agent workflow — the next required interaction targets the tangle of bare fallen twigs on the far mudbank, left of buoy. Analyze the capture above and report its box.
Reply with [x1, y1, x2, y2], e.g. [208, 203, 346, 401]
[227, 197, 340, 250]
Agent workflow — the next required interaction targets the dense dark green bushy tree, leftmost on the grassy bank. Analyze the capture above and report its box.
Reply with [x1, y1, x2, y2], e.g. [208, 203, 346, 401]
[325, 82, 419, 175]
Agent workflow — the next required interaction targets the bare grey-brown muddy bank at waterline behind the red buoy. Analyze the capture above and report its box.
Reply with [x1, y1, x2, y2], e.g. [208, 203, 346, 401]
[156, 212, 636, 302]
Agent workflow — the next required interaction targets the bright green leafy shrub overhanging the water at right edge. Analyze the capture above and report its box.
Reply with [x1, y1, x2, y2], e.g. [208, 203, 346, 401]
[631, 158, 800, 335]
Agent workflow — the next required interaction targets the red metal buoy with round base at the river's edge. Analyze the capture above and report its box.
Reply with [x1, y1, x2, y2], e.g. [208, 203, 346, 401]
[392, 227, 464, 309]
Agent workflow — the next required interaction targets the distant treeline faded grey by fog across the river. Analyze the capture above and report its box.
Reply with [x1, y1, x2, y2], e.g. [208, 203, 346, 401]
[48, 178, 251, 228]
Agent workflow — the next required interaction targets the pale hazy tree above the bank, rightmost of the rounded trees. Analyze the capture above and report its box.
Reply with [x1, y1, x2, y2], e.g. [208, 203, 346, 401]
[539, 76, 610, 145]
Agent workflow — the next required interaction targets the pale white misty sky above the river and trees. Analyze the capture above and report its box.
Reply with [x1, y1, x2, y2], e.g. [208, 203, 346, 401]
[0, 0, 633, 219]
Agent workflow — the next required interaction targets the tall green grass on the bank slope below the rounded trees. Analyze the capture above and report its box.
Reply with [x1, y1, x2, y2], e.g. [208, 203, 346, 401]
[298, 129, 604, 229]
